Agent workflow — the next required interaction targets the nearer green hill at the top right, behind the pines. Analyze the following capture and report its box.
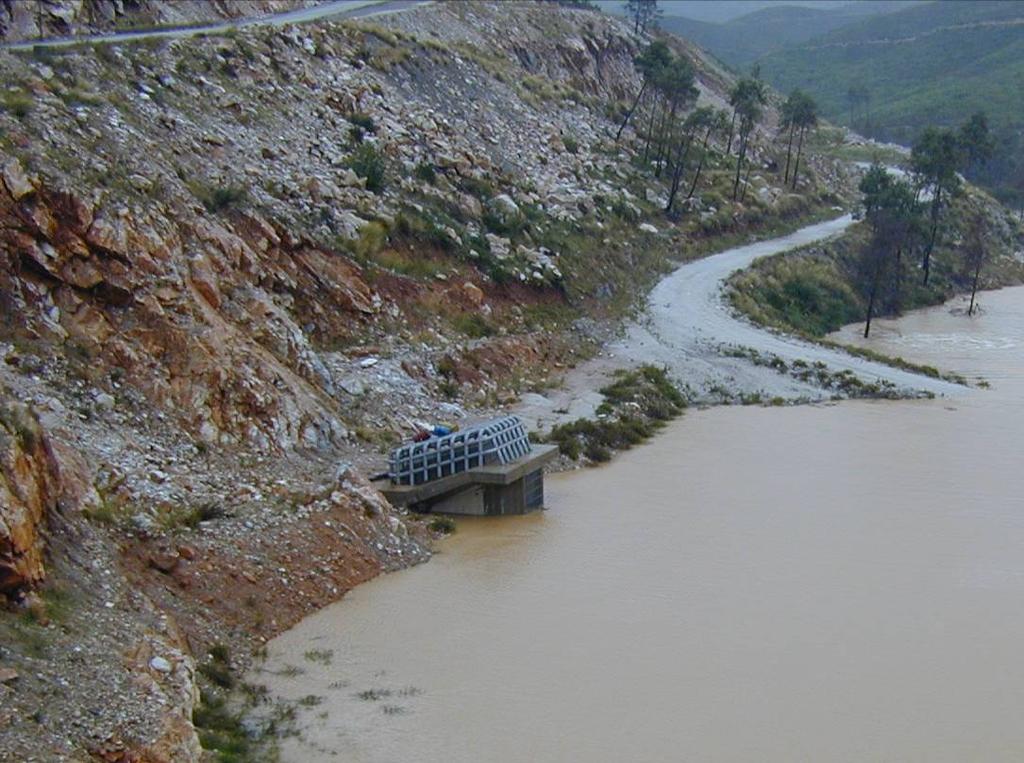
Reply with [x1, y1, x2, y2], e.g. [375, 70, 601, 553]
[760, 0, 1024, 199]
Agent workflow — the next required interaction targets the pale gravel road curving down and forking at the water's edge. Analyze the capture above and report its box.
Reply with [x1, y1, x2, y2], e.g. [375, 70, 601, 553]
[516, 210, 967, 428]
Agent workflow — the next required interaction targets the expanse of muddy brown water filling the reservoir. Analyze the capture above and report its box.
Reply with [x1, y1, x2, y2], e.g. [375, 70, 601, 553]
[260, 289, 1024, 763]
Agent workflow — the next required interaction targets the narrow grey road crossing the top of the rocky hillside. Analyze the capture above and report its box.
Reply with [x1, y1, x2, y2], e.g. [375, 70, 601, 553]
[0, 0, 433, 50]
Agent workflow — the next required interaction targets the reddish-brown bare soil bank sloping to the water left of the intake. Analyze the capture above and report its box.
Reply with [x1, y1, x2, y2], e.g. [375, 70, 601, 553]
[122, 471, 430, 658]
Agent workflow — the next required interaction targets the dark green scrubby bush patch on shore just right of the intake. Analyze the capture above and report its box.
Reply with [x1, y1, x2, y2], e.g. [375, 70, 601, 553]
[544, 366, 686, 463]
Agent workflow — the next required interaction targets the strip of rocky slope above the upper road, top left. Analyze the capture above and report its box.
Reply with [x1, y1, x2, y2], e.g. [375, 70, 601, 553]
[0, 0, 317, 42]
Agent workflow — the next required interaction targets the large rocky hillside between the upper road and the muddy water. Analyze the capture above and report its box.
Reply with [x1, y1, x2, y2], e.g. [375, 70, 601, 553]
[0, 3, 845, 761]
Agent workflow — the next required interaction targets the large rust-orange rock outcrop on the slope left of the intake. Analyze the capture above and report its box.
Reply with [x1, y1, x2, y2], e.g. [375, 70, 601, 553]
[0, 160, 379, 451]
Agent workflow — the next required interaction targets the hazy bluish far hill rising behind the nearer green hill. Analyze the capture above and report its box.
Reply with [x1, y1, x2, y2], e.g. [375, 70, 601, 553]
[660, 0, 911, 69]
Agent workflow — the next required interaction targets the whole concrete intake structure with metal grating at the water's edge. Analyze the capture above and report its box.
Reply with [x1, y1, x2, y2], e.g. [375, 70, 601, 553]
[382, 416, 558, 516]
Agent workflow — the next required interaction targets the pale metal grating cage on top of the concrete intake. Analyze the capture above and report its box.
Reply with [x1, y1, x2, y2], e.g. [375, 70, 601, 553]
[388, 416, 530, 484]
